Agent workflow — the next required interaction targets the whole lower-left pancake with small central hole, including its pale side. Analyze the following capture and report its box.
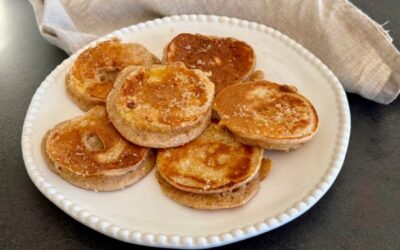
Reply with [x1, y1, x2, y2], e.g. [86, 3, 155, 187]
[43, 106, 153, 191]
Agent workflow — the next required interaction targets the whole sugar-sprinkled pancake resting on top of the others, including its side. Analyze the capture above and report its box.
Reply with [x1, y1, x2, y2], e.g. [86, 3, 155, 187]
[107, 63, 214, 148]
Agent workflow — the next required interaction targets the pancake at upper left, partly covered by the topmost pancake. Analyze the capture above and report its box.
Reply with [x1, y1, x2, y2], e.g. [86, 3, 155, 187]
[66, 38, 160, 111]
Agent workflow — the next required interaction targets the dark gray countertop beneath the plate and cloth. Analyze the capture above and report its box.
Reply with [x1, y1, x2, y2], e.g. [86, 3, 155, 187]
[0, 0, 400, 249]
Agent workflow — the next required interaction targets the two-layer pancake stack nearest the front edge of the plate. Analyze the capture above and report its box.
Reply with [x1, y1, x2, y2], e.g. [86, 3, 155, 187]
[157, 123, 271, 209]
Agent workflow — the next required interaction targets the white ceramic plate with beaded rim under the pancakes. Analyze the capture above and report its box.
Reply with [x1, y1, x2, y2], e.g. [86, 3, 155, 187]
[22, 15, 350, 248]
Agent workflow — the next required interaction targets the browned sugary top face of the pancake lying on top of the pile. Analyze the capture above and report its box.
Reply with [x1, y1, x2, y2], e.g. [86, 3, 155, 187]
[116, 64, 214, 130]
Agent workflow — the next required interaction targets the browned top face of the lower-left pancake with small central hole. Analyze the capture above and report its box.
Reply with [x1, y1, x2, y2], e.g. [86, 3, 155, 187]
[45, 106, 149, 175]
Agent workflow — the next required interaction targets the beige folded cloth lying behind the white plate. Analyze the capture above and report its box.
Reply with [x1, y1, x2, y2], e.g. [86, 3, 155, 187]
[30, 0, 400, 104]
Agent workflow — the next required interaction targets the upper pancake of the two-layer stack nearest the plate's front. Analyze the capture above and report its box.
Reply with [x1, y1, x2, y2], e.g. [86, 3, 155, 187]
[156, 124, 263, 193]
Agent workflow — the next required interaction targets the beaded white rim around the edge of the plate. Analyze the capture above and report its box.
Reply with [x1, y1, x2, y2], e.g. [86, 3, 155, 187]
[21, 14, 351, 249]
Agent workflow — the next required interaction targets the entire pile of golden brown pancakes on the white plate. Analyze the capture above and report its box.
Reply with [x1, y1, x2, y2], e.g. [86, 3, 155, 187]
[43, 34, 318, 209]
